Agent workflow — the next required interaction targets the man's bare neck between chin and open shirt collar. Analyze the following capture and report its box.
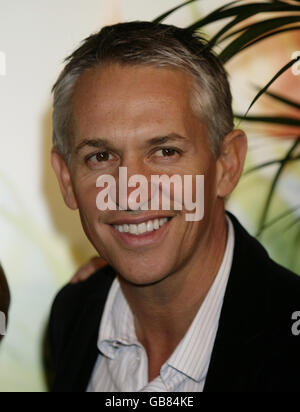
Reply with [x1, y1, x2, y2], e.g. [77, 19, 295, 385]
[120, 211, 227, 360]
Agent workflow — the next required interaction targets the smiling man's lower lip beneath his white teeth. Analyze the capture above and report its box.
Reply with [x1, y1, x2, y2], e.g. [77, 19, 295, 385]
[108, 216, 174, 248]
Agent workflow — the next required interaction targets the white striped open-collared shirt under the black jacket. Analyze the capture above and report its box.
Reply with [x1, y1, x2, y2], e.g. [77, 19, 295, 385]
[87, 218, 234, 392]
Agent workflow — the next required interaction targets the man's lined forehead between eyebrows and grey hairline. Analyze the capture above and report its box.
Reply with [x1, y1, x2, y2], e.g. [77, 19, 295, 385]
[73, 64, 205, 146]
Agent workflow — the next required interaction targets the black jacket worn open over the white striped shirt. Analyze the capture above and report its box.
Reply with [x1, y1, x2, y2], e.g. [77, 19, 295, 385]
[49, 215, 300, 392]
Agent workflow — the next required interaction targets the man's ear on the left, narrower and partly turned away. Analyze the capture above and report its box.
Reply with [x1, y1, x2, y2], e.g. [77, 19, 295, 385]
[51, 149, 78, 210]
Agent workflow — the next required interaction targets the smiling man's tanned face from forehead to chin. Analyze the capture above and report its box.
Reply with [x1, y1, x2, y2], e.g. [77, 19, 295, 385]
[61, 64, 225, 285]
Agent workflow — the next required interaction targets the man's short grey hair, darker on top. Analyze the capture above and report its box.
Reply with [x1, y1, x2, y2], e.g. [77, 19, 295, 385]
[53, 21, 234, 161]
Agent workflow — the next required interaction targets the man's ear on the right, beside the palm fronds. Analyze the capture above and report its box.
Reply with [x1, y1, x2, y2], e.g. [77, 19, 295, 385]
[217, 130, 247, 198]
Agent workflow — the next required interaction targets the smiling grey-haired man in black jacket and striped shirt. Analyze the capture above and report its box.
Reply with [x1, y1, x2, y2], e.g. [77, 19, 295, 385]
[49, 22, 300, 392]
